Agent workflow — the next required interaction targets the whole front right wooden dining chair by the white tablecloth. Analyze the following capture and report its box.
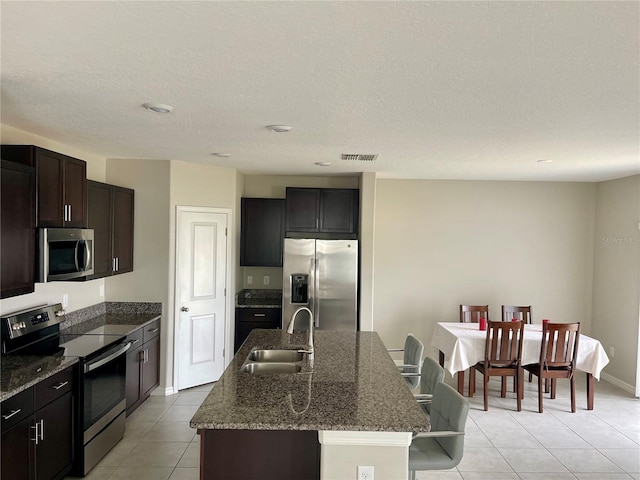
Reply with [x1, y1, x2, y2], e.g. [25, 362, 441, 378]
[514, 322, 580, 413]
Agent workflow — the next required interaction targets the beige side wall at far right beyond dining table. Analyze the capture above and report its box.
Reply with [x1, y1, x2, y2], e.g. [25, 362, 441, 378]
[592, 175, 640, 388]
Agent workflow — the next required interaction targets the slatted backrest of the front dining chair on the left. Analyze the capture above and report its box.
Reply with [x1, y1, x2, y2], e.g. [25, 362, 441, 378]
[484, 322, 524, 368]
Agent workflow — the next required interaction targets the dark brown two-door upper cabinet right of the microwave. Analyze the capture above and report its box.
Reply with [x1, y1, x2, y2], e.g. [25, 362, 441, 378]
[87, 180, 135, 279]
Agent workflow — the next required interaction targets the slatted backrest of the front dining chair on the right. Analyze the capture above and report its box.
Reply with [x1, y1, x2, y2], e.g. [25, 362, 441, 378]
[540, 322, 580, 369]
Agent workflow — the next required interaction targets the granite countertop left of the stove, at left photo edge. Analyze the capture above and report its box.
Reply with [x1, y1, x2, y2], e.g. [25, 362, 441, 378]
[0, 355, 78, 402]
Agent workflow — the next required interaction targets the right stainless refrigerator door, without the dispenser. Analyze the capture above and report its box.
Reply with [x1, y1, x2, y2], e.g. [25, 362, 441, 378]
[314, 240, 358, 332]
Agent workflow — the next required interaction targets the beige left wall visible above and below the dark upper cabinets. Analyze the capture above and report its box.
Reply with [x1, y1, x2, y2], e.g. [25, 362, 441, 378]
[0, 125, 106, 313]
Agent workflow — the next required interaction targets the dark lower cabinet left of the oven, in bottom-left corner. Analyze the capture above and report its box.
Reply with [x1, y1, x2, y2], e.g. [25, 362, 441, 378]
[0, 367, 75, 480]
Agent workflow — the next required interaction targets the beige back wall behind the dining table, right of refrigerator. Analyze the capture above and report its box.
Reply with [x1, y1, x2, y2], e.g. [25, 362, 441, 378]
[373, 180, 596, 356]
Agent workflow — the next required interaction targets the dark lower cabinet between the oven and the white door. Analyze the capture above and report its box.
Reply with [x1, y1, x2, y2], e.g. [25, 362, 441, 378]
[125, 319, 160, 416]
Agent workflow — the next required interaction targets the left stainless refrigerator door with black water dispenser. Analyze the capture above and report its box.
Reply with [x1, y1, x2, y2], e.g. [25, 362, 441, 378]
[282, 238, 316, 331]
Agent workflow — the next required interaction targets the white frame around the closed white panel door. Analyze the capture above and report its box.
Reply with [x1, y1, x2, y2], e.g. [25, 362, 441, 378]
[172, 205, 234, 393]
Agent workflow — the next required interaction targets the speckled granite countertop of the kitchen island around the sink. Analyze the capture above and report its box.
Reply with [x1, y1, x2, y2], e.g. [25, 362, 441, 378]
[190, 329, 430, 432]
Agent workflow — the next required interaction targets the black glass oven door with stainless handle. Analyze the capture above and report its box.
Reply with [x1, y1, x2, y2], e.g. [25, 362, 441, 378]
[83, 343, 131, 443]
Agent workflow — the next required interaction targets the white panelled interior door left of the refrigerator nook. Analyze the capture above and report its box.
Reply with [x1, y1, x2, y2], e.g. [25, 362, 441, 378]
[176, 209, 228, 390]
